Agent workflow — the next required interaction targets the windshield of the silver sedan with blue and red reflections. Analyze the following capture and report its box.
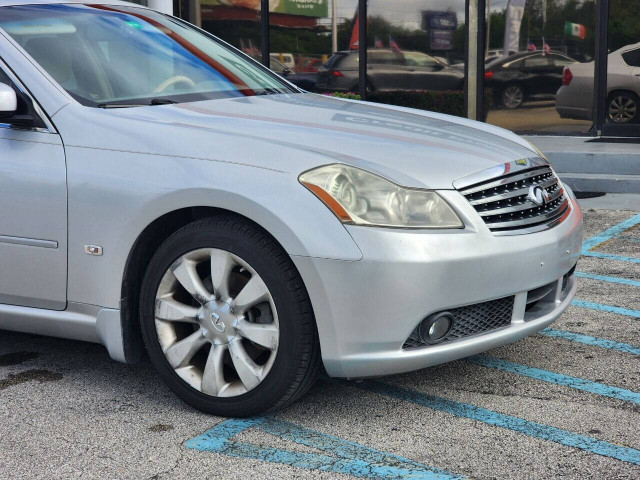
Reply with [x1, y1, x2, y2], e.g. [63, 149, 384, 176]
[0, 4, 298, 108]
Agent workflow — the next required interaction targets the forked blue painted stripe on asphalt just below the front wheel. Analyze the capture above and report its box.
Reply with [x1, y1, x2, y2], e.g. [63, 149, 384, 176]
[185, 417, 466, 480]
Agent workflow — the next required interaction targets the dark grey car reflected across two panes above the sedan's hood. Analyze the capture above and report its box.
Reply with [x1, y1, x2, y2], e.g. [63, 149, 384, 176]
[316, 49, 464, 92]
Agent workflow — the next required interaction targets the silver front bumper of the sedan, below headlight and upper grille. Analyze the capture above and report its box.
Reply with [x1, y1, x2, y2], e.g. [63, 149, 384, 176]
[292, 191, 582, 378]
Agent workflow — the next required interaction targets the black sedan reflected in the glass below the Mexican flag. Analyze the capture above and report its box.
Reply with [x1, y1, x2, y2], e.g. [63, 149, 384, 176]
[484, 51, 577, 108]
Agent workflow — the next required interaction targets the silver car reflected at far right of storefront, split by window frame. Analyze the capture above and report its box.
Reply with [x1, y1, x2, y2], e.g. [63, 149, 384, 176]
[556, 43, 640, 123]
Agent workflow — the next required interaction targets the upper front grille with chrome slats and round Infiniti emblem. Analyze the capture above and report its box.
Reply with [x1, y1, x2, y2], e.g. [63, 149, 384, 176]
[458, 161, 570, 235]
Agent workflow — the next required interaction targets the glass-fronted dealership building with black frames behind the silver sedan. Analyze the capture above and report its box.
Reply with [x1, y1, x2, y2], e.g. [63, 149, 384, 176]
[144, 0, 640, 193]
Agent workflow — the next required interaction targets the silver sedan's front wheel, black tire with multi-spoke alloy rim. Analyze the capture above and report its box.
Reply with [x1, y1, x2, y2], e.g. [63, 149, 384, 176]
[140, 215, 321, 417]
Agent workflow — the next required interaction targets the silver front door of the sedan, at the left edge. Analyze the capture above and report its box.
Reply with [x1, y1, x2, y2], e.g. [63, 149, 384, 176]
[0, 60, 67, 310]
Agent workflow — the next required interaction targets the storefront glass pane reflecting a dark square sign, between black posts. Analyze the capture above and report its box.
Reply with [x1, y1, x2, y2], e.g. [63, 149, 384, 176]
[364, 0, 466, 116]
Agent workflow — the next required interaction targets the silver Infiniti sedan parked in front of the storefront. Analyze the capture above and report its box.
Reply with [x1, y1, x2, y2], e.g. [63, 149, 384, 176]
[0, 0, 582, 416]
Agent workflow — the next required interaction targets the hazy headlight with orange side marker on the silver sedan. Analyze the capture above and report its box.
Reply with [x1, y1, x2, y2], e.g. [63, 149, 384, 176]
[298, 164, 464, 228]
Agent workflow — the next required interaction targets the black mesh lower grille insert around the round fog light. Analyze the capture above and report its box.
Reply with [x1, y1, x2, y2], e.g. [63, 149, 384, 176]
[402, 296, 514, 349]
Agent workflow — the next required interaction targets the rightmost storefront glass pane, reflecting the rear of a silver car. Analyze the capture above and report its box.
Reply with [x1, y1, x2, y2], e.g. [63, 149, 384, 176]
[605, 0, 640, 127]
